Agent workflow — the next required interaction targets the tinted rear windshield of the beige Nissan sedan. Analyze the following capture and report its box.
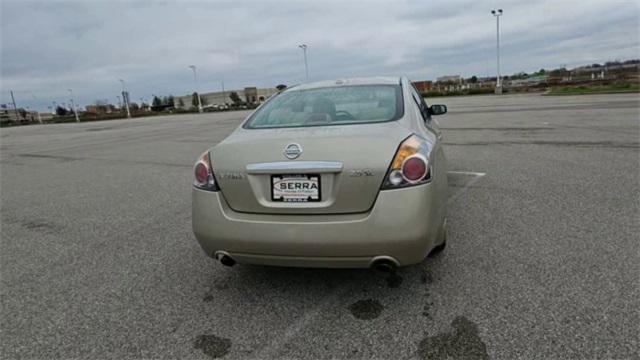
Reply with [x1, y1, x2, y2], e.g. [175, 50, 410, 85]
[244, 85, 404, 129]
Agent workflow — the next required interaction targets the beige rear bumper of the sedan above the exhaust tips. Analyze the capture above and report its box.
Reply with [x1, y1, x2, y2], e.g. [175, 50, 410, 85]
[192, 184, 446, 268]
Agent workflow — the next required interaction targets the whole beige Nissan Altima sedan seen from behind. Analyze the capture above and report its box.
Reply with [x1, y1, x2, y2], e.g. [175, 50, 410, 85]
[192, 77, 447, 268]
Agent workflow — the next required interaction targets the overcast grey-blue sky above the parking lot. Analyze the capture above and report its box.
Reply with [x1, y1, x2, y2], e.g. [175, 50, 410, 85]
[0, 0, 640, 110]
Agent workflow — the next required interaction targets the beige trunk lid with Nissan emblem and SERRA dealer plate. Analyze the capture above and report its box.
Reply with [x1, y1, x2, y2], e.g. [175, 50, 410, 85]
[211, 121, 409, 214]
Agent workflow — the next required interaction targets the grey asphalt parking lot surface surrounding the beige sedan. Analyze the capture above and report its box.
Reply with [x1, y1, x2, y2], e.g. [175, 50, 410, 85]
[0, 94, 640, 359]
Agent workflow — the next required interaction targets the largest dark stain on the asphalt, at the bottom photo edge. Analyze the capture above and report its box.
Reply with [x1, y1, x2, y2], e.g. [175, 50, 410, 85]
[418, 316, 489, 360]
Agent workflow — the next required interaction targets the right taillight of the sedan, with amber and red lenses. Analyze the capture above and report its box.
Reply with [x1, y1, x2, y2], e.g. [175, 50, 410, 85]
[382, 135, 431, 190]
